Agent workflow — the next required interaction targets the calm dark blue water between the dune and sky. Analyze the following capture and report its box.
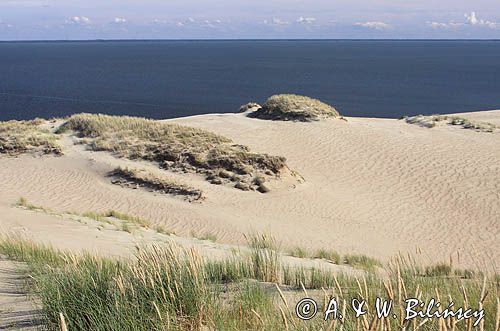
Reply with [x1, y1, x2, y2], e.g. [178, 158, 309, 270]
[0, 41, 500, 120]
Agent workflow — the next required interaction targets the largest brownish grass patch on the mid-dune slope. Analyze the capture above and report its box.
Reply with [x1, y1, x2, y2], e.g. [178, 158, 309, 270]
[58, 114, 287, 190]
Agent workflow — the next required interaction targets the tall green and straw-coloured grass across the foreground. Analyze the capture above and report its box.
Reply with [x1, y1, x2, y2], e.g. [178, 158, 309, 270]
[0, 238, 500, 331]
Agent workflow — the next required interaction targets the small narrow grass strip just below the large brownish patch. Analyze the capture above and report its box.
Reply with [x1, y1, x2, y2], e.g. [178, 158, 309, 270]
[109, 167, 204, 202]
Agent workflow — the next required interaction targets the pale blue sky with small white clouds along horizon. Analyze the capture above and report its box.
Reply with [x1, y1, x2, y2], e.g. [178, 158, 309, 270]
[0, 0, 500, 40]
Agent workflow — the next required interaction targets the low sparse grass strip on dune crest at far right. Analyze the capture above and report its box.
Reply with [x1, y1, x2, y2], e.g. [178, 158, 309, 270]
[404, 115, 498, 132]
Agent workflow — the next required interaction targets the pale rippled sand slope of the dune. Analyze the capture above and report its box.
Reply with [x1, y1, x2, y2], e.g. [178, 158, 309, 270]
[0, 111, 500, 270]
